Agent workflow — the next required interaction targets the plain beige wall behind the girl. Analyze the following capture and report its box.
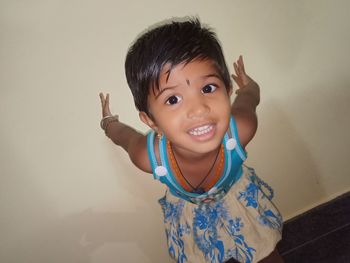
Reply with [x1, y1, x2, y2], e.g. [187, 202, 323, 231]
[0, 0, 350, 263]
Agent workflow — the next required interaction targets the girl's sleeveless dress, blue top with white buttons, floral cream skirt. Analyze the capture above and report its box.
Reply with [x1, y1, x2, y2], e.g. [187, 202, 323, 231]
[148, 117, 282, 263]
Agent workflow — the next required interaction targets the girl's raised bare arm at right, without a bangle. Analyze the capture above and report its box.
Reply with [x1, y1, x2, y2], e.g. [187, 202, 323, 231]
[231, 56, 260, 148]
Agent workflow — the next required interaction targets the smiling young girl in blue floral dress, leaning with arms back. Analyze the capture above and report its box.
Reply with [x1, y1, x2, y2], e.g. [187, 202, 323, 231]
[100, 19, 282, 262]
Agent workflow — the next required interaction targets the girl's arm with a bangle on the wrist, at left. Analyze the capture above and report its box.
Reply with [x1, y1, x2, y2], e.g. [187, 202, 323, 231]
[100, 93, 152, 173]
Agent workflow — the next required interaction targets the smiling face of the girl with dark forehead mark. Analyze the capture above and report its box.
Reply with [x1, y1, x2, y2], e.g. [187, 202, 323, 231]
[140, 60, 231, 157]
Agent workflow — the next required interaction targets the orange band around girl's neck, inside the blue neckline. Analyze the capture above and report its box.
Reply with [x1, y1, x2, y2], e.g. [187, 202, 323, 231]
[167, 141, 225, 194]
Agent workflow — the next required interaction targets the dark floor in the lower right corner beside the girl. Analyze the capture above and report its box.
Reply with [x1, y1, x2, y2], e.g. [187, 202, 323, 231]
[278, 192, 350, 263]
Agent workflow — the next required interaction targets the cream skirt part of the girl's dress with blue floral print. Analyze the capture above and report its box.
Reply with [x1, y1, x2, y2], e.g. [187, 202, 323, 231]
[159, 170, 282, 263]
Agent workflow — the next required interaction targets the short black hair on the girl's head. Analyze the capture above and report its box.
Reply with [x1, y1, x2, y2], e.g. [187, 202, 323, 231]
[125, 18, 232, 114]
